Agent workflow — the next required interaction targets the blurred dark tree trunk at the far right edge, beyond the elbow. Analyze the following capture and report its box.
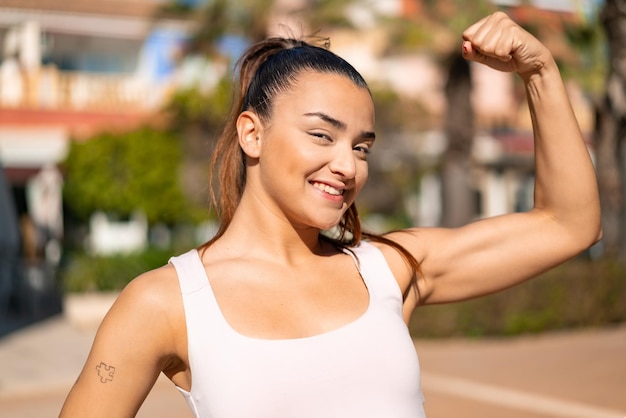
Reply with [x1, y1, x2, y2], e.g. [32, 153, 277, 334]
[595, 0, 626, 259]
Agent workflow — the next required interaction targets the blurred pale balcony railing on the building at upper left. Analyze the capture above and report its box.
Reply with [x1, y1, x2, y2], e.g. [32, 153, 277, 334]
[0, 63, 168, 112]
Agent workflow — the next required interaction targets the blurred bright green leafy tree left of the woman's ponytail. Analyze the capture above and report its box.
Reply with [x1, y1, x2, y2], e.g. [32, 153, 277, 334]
[64, 128, 198, 224]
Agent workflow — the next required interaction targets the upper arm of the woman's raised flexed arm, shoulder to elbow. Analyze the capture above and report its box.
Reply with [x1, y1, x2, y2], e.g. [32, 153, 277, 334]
[390, 211, 584, 304]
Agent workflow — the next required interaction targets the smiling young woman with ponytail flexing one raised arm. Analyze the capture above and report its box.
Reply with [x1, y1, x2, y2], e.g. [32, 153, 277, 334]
[61, 13, 600, 418]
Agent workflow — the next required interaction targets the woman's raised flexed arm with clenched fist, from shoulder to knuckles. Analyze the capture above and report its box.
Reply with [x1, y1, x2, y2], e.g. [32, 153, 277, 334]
[387, 13, 600, 305]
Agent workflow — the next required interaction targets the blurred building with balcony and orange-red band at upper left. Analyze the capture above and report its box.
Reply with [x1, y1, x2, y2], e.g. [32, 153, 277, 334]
[0, 0, 190, 320]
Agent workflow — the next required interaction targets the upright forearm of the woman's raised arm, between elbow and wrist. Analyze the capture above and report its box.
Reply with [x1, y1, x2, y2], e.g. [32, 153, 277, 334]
[524, 60, 600, 240]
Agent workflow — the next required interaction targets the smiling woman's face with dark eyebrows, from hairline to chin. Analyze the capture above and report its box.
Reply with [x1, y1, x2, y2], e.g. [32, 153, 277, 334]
[249, 71, 374, 229]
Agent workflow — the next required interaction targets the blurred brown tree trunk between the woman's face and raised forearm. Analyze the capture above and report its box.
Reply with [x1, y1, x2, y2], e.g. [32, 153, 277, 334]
[442, 53, 475, 227]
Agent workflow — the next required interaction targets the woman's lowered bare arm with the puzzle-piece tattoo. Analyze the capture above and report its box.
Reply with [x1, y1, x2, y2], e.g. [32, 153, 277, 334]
[60, 266, 182, 418]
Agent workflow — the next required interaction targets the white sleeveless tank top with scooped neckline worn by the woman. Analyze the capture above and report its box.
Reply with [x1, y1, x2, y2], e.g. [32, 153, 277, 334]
[170, 242, 425, 418]
